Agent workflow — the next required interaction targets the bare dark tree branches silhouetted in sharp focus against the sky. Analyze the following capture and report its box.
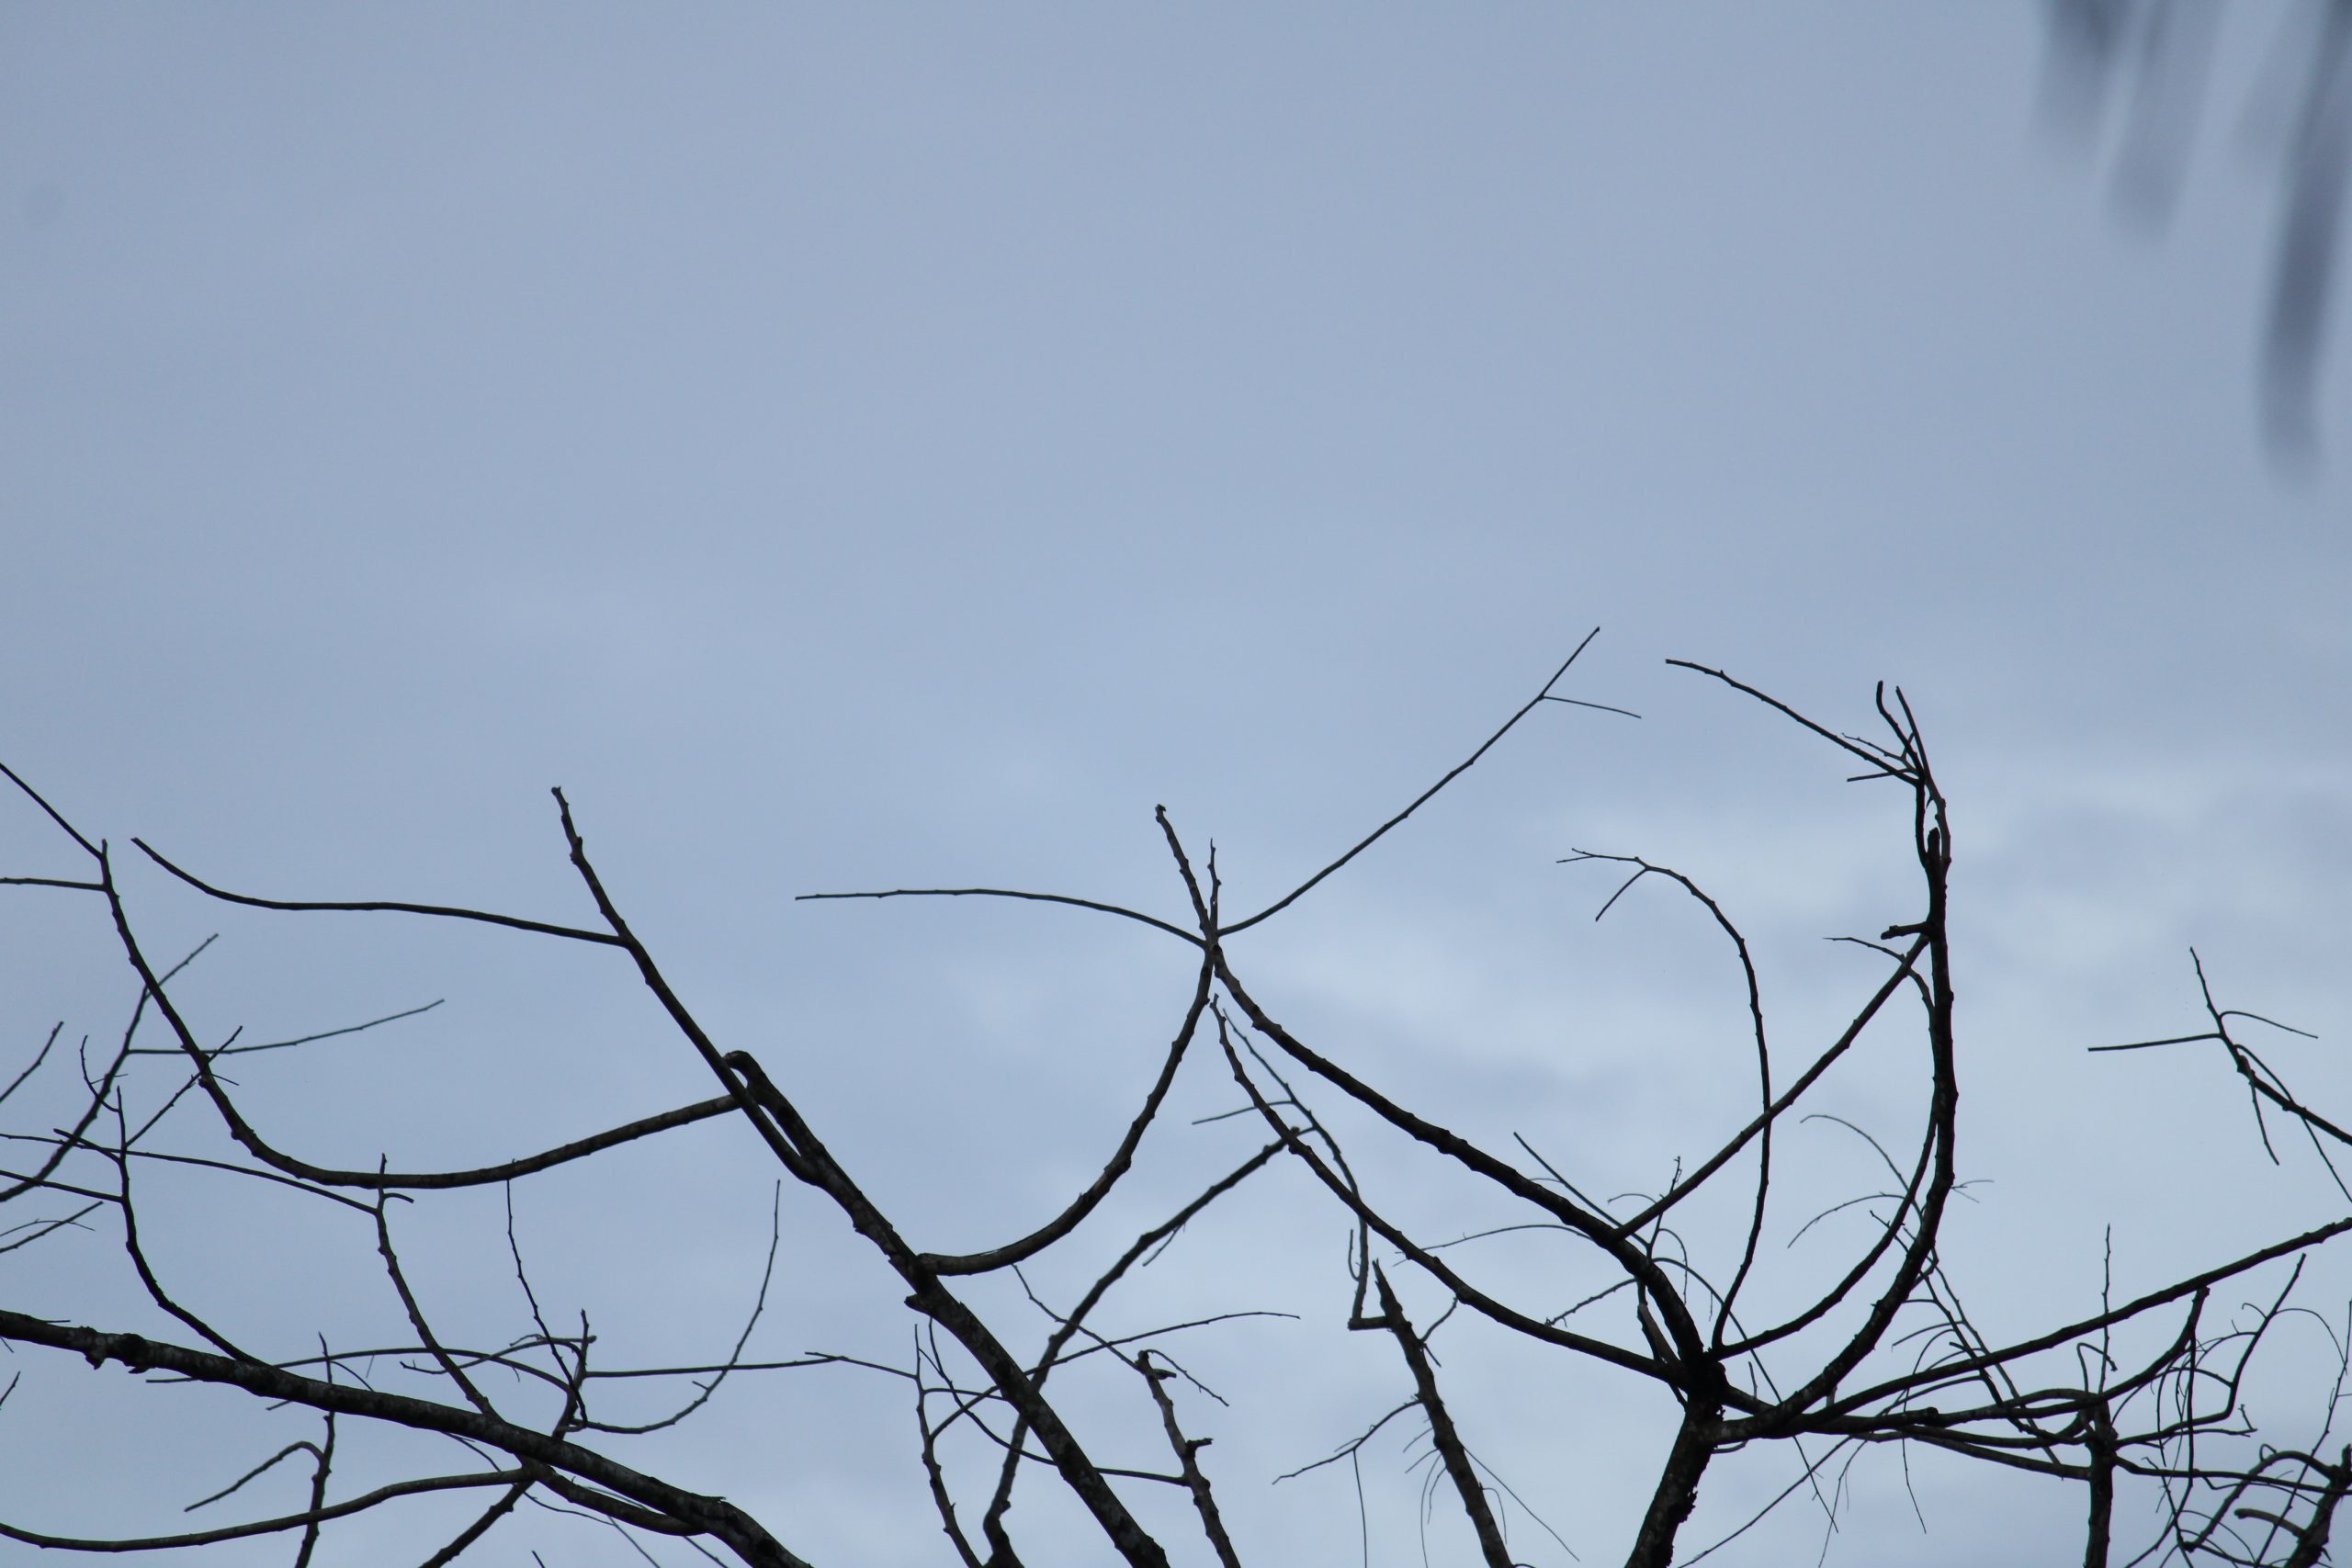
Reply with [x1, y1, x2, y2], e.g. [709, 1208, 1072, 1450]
[0, 637, 2352, 1568]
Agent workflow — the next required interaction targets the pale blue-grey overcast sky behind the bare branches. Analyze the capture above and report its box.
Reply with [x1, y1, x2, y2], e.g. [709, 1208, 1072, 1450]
[0, 3, 2352, 1563]
